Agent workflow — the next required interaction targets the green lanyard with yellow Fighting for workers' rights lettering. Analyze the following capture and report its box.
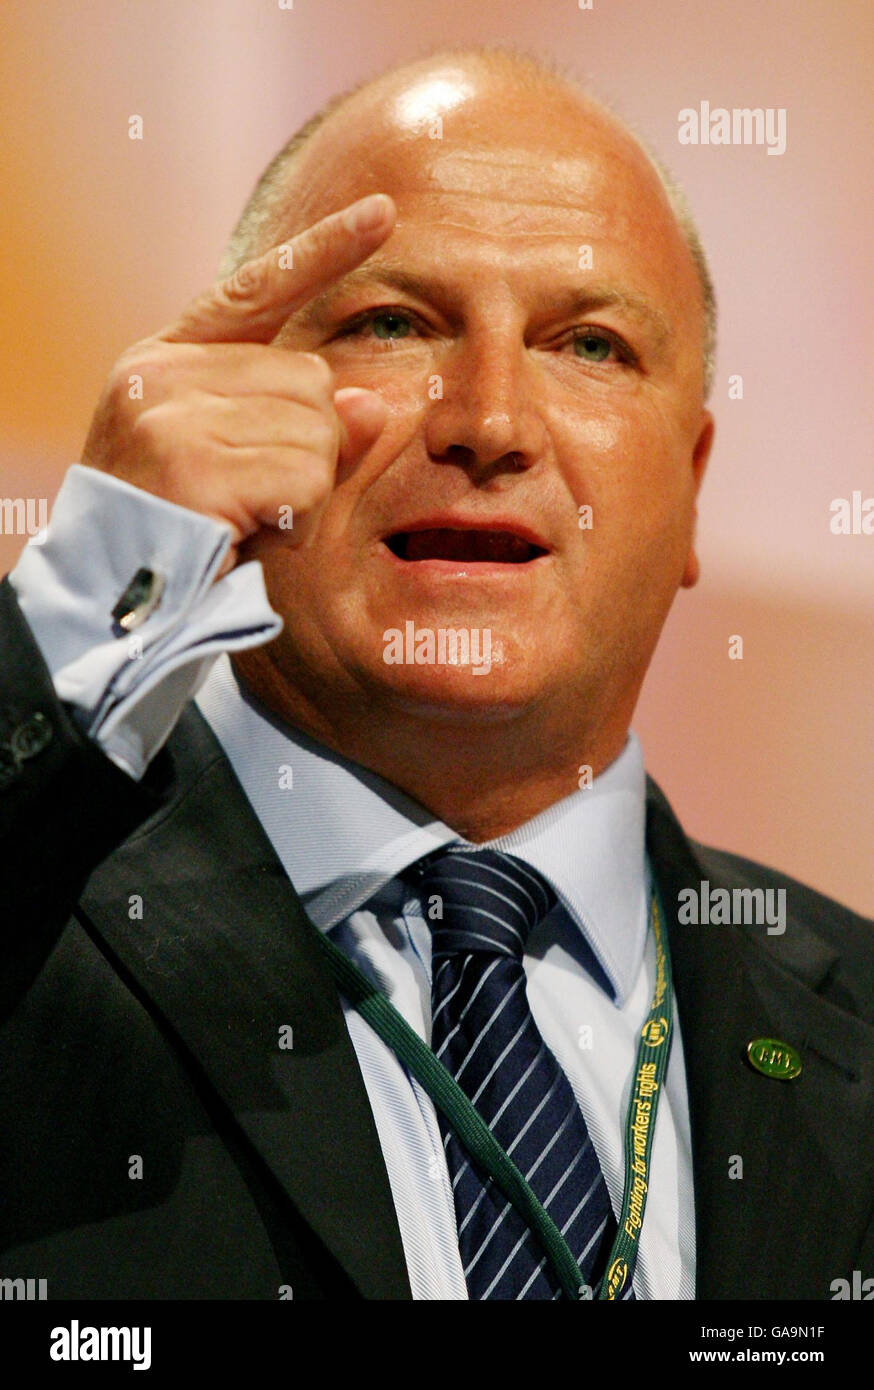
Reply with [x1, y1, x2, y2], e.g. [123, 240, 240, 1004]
[304, 880, 673, 1301]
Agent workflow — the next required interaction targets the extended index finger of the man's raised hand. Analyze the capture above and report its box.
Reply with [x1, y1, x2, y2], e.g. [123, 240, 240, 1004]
[156, 193, 396, 343]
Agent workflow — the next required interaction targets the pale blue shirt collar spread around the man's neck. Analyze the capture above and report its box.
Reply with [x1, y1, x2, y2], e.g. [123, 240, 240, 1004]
[197, 656, 648, 1006]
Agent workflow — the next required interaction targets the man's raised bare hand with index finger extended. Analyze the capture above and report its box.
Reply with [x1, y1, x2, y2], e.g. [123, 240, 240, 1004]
[82, 193, 395, 573]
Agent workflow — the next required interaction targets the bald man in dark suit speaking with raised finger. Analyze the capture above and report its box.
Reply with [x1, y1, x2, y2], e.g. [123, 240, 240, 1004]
[0, 43, 874, 1300]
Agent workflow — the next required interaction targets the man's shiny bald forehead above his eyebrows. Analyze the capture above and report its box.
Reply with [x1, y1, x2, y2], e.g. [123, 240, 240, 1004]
[271, 67, 698, 304]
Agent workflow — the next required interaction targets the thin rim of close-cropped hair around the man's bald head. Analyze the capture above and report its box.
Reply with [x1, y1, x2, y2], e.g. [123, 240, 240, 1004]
[220, 44, 717, 398]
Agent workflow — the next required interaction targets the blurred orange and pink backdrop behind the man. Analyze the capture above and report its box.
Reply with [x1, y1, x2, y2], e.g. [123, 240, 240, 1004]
[0, 0, 874, 913]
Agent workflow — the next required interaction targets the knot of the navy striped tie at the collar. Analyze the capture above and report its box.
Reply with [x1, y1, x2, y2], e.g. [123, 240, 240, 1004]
[420, 845, 556, 960]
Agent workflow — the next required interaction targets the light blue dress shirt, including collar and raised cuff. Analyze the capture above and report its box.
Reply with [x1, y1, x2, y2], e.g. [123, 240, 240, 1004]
[11, 467, 695, 1300]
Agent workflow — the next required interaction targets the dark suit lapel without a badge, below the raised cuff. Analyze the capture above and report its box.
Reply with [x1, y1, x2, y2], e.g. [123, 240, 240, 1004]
[82, 709, 410, 1298]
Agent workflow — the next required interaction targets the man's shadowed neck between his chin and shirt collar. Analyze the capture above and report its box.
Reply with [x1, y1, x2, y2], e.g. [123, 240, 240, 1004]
[227, 649, 631, 844]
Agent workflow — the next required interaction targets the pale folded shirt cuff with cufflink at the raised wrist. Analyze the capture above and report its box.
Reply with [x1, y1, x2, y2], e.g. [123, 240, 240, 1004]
[10, 464, 282, 778]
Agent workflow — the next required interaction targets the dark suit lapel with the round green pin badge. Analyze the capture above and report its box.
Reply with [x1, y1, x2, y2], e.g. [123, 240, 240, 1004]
[648, 784, 874, 1300]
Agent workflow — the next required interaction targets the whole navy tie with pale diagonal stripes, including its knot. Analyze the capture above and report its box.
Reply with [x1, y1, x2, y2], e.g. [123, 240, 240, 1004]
[418, 847, 616, 1300]
